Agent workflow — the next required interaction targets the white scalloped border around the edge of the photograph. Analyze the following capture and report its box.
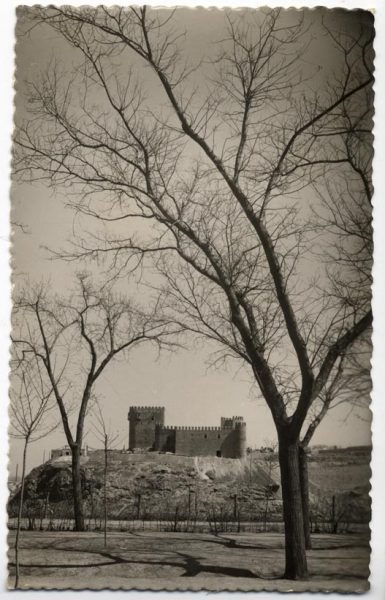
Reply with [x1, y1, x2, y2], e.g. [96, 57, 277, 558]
[0, 0, 385, 600]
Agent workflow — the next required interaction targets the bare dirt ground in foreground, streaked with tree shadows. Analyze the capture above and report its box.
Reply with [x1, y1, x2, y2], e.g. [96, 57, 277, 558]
[9, 532, 369, 592]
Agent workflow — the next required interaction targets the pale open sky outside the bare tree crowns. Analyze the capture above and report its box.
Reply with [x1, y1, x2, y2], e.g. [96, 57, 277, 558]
[10, 4, 370, 473]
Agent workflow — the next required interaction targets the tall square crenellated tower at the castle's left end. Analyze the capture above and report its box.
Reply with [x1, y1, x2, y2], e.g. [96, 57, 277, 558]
[128, 406, 164, 450]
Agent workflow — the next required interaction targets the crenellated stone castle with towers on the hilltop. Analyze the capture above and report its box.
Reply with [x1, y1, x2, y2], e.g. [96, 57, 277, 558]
[128, 406, 246, 458]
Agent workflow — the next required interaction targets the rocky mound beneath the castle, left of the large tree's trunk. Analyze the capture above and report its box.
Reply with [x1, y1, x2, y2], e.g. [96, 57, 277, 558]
[9, 451, 280, 519]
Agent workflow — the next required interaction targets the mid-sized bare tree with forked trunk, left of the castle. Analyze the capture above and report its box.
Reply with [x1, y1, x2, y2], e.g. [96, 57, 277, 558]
[12, 275, 171, 531]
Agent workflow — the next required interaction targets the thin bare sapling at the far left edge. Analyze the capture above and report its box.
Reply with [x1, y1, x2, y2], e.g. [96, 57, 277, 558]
[9, 358, 58, 588]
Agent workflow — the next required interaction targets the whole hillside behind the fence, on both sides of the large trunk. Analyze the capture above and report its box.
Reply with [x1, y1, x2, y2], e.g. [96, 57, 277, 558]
[9, 448, 370, 521]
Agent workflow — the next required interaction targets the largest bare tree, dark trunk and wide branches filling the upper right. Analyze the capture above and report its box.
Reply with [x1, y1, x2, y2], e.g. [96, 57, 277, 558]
[14, 7, 373, 579]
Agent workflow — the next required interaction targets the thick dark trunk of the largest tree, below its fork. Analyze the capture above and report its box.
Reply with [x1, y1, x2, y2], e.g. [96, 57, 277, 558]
[279, 435, 308, 579]
